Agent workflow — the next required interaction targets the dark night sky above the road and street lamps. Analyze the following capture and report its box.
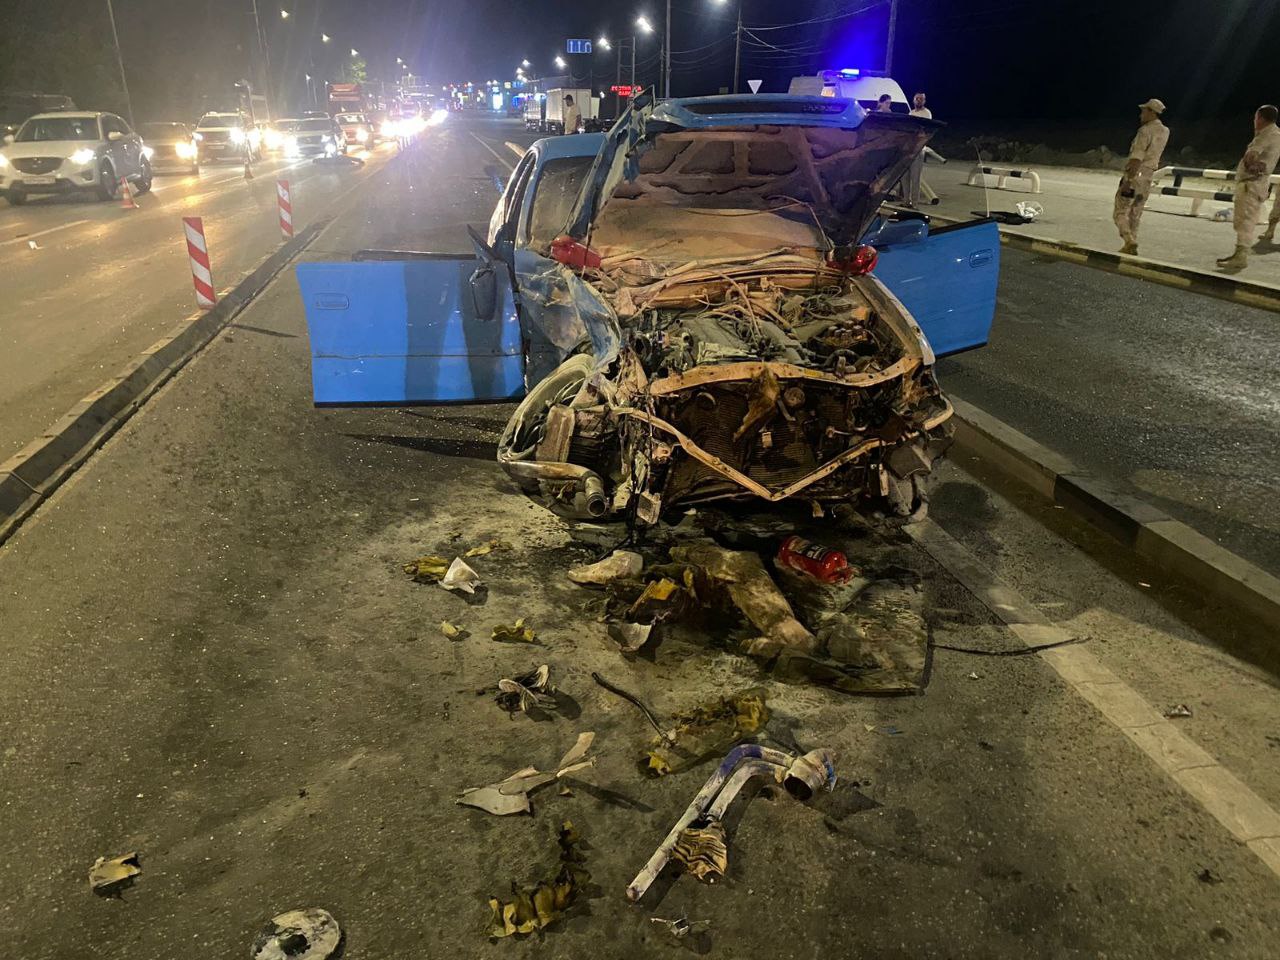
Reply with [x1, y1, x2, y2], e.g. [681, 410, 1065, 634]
[0, 0, 1280, 125]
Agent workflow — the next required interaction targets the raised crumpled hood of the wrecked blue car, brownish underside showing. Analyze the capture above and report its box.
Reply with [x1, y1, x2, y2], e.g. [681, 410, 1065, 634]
[568, 93, 941, 252]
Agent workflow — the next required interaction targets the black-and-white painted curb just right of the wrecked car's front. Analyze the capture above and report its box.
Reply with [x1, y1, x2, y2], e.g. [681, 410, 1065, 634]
[950, 396, 1280, 628]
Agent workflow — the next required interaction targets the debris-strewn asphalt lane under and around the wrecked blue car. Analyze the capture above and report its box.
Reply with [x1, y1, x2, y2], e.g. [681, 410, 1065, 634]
[0, 120, 1280, 960]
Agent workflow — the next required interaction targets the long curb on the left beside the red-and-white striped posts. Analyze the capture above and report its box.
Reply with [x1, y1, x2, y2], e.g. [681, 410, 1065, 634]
[0, 216, 334, 543]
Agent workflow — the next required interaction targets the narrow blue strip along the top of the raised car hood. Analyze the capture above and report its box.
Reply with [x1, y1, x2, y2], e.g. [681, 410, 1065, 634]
[649, 93, 867, 129]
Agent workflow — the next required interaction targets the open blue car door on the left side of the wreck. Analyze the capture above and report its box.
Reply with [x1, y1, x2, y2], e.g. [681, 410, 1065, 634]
[297, 232, 525, 406]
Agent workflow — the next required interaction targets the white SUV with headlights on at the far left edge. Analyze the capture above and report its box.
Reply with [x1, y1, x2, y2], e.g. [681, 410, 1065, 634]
[0, 111, 151, 205]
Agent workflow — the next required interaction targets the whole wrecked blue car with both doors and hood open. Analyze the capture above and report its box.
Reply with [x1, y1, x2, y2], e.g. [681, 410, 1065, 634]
[297, 95, 1000, 524]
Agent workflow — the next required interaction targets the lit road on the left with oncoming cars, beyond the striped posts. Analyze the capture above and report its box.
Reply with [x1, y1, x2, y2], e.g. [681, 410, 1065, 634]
[0, 143, 396, 461]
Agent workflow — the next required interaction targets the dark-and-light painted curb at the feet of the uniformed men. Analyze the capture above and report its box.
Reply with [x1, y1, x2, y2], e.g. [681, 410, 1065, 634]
[929, 214, 1280, 314]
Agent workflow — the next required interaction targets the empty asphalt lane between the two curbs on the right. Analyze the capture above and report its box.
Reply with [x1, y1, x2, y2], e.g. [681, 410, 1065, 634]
[938, 248, 1280, 573]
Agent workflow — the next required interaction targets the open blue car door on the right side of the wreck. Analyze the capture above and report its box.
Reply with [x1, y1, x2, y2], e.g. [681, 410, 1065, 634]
[874, 220, 1000, 357]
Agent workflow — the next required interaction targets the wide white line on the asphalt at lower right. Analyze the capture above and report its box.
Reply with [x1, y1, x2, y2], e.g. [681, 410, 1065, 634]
[908, 521, 1280, 876]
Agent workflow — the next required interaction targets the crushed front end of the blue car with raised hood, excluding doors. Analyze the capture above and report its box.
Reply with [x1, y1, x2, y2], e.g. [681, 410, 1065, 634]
[499, 97, 951, 524]
